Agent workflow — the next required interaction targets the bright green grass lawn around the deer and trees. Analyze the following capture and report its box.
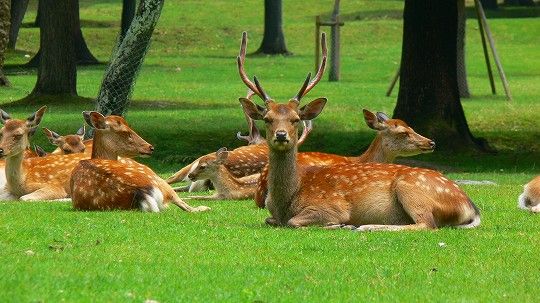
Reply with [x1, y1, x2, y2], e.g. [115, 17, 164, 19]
[0, 0, 540, 302]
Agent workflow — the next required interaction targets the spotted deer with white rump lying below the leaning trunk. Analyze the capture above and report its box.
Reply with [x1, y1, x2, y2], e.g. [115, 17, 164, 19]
[69, 111, 210, 212]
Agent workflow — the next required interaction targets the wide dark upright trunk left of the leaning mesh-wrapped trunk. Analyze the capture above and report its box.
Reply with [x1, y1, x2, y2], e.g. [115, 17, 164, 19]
[31, 0, 78, 96]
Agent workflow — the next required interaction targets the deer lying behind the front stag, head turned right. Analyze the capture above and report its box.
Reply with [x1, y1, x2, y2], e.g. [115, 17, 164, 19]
[255, 109, 435, 208]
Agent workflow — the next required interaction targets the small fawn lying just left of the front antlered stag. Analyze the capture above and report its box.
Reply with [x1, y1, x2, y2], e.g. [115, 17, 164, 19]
[188, 147, 259, 200]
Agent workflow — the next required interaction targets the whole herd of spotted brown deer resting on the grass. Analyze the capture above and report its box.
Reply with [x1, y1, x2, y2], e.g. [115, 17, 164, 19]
[0, 33, 540, 231]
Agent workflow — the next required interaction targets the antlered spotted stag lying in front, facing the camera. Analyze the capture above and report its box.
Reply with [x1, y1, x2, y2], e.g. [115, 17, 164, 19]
[237, 32, 480, 231]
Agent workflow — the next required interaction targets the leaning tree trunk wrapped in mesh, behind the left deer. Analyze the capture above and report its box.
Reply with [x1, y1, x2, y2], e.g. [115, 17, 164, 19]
[96, 0, 164, 116]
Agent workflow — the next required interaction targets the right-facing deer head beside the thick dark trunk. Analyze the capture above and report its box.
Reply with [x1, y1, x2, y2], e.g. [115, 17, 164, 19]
[363, 109, 435, 156]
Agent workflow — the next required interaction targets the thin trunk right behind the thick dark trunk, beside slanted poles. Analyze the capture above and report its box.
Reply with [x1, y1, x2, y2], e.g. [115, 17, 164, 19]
[457, 0, 471, 98]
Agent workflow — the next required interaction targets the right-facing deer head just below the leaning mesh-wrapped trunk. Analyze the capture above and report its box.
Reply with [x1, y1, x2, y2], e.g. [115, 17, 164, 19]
[83, 112, 154, 157]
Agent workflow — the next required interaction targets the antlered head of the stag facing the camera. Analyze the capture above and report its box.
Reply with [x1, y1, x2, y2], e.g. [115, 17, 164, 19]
[237, 32, 327, 151]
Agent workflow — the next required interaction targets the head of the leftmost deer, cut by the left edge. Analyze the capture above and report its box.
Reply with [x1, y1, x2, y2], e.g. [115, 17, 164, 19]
[0, 106, 47, 158]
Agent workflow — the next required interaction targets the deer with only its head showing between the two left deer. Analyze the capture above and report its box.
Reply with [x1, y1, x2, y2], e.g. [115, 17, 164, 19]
[43, 125, 92, 155]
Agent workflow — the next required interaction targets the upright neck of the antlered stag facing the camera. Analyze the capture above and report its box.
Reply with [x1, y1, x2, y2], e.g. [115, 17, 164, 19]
[268, 147, 300, 225]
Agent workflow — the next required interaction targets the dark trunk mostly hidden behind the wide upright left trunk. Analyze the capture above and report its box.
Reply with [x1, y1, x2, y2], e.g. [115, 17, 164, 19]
[26, 0, 99, 67]
